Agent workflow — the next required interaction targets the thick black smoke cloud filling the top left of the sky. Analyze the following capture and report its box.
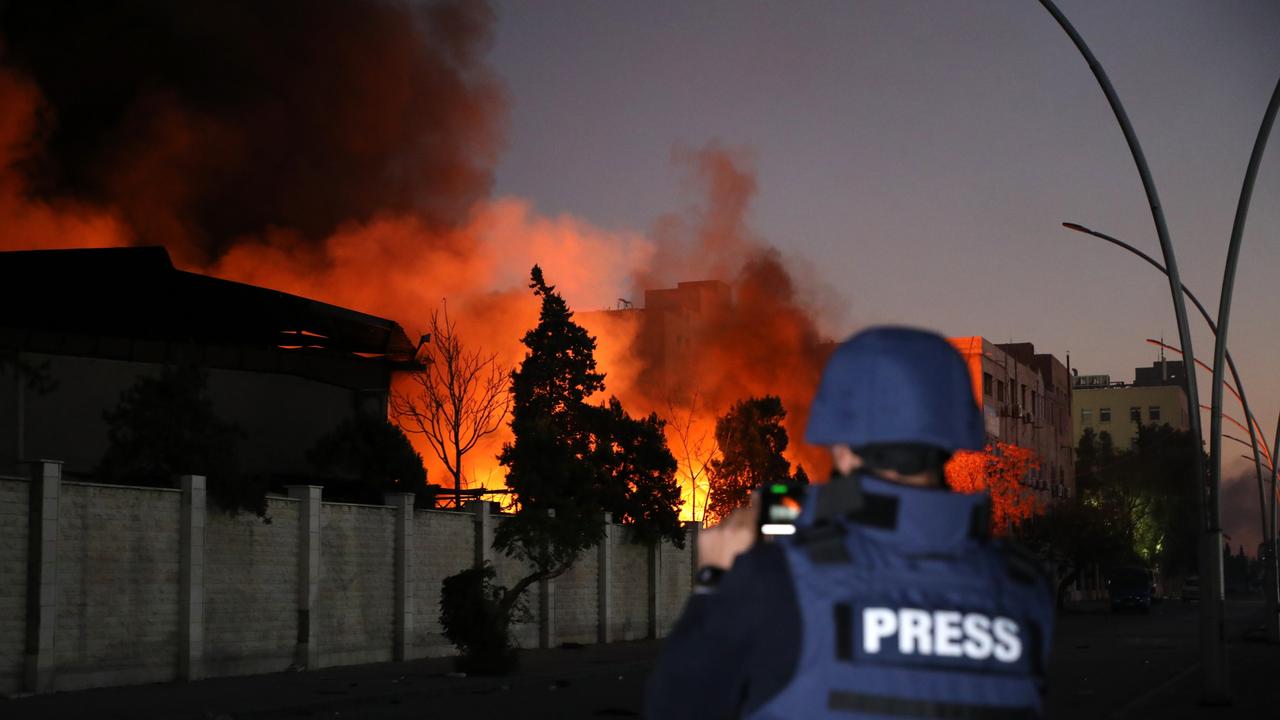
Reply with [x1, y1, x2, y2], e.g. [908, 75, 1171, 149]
[0, 0, 503, 263]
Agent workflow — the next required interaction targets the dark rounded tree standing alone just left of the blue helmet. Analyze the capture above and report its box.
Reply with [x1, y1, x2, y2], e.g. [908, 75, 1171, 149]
[707, 395, 808, 518]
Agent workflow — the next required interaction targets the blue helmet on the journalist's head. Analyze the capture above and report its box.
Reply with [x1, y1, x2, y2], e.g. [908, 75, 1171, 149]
[805, 327, 986, 452]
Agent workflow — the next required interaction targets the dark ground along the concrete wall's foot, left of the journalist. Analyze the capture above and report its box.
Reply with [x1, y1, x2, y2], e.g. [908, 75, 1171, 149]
[0, 641, 660, 720]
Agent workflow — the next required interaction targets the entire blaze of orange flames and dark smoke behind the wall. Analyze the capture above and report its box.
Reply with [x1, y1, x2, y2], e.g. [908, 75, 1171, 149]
[0, 0, 827, 520]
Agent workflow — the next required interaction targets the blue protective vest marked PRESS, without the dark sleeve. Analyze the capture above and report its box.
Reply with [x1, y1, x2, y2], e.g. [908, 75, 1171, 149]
[750, 477, 1053, 720]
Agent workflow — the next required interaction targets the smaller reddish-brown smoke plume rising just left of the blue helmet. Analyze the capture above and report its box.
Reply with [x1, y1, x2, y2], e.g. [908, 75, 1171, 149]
[616, 143, 831, 477]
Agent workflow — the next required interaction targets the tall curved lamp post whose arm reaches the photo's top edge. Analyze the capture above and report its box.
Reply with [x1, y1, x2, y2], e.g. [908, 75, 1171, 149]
[1041, 0, 1213, 705]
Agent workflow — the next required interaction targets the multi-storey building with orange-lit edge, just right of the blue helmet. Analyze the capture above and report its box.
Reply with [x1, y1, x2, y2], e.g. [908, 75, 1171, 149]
[950, 336, 1075, 498]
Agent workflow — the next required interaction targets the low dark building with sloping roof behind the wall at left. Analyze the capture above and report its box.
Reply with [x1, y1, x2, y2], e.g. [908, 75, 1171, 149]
[0, 247, 416, 479]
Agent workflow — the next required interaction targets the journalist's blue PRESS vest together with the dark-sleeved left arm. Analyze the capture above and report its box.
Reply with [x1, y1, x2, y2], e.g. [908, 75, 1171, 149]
[646, 475, 1053, 720]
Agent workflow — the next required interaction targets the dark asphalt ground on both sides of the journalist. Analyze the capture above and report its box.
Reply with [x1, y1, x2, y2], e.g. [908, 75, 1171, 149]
[0, 600, 1280, 720]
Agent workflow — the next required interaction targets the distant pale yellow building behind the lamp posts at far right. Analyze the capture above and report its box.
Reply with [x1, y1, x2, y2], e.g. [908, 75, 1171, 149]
[1071, 360, 1189, 450]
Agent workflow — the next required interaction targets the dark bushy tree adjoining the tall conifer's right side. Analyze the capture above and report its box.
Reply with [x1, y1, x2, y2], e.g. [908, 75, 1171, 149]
[588, 397, 685, 547]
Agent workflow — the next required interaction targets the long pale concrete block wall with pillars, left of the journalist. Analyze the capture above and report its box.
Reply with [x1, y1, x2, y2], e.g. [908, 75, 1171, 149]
[0, 462, 692, 694]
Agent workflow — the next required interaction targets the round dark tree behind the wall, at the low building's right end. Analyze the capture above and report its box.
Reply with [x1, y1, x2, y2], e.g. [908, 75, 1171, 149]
[307, 413, 435, 507]
